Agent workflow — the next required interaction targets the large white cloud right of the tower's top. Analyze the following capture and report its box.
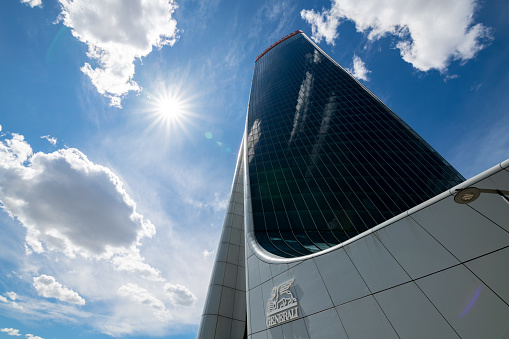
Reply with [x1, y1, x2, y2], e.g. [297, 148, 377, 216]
[301, 0, 491, 71]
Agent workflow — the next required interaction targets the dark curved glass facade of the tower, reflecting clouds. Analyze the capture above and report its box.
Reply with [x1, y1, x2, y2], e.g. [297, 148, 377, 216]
[246, 33, 464, 257]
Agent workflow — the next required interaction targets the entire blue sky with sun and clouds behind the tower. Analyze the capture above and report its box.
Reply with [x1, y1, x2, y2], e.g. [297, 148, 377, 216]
[0, 0, 509, 339]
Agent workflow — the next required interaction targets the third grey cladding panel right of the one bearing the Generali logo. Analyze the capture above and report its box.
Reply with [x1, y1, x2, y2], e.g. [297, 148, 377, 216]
[345, 235, 410, 293]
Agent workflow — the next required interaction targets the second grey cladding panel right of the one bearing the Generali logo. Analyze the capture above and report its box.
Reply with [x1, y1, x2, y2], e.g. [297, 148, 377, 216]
[314, 248, 370, 306]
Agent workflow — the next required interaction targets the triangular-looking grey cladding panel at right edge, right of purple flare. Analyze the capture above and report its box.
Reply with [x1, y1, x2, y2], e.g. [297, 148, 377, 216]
[465, 247, 509, 304]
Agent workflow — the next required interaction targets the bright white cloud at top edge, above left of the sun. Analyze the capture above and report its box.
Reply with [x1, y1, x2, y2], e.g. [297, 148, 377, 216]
[54, 0, 178, 107]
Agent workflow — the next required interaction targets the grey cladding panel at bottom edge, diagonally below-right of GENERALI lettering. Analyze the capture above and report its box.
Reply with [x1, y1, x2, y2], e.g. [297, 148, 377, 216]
[304, 308, 348, 339]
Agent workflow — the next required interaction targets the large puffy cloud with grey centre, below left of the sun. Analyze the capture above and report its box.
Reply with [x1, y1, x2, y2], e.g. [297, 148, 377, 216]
[0, 134, 155, 258]
